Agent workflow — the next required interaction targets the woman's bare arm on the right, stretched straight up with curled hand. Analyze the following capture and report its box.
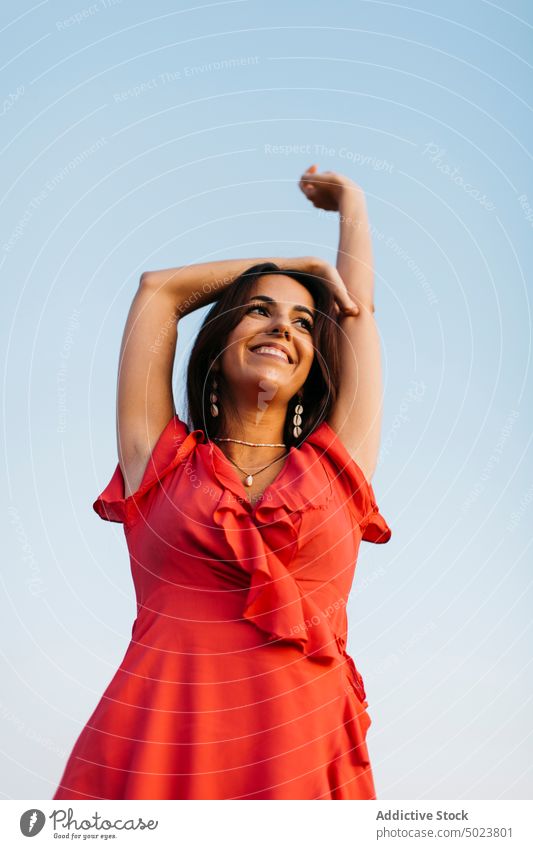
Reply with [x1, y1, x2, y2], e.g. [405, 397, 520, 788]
[300, 166, 382, 481]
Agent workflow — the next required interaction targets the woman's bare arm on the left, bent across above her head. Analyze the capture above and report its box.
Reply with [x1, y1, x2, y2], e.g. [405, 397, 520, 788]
[117, 257, 324, 496]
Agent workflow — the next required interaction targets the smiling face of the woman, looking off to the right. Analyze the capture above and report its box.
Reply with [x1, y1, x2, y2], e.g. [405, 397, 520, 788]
[220, 274, 315, 403]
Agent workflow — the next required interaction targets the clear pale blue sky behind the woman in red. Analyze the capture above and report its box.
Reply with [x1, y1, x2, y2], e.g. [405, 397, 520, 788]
[0, 0, 533, 799]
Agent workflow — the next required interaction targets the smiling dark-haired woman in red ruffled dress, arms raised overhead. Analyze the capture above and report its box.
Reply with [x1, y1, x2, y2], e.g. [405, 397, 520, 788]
[53, 166, 391, 799]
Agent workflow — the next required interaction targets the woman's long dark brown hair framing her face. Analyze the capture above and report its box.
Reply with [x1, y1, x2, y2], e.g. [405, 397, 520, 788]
[186, 262, 340, 446]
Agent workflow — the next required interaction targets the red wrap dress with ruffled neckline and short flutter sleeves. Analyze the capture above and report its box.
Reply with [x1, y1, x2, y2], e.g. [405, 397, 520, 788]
[53, 416, 391, 799]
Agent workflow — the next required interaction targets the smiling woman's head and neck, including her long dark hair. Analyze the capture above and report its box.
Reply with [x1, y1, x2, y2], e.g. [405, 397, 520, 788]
[187, 260, 348, 484]
